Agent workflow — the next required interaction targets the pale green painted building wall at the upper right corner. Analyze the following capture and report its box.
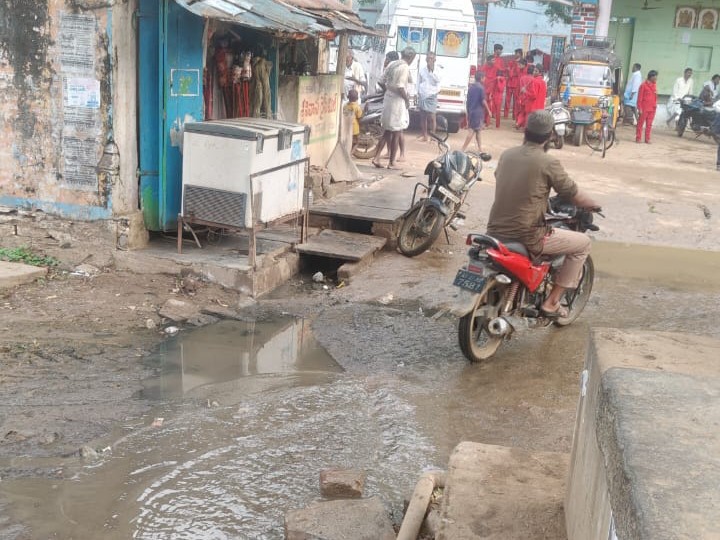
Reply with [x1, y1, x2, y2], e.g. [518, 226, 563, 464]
[611, 0, 720, 95]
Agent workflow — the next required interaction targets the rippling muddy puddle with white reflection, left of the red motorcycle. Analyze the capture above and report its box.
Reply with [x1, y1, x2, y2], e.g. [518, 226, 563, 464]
[0, 319, 435, 539]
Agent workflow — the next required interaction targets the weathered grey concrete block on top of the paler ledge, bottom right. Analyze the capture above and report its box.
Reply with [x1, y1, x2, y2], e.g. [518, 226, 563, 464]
[597, 368, 720, 540]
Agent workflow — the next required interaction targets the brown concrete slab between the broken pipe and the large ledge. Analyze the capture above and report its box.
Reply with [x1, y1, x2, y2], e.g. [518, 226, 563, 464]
[436, 442, 568, 540]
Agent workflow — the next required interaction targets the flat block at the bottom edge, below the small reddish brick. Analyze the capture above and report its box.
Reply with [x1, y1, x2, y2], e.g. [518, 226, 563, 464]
[285, 497, 395, 540]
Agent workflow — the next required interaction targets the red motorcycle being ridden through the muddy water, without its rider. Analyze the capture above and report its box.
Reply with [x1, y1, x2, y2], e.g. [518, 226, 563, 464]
[451, 197, 602, 362]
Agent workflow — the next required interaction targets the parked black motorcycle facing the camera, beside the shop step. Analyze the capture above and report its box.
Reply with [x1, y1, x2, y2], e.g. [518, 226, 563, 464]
[397, 116, 492, 257]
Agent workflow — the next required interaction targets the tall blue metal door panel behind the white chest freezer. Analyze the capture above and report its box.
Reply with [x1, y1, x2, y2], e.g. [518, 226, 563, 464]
[138, 0, 204, 231]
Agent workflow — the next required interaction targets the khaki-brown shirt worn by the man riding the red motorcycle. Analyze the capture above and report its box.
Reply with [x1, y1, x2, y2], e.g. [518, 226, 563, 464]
[487, 142, 578, 254]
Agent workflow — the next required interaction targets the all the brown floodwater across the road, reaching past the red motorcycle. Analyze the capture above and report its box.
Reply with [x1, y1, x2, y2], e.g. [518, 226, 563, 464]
[0, 245, 720, 539]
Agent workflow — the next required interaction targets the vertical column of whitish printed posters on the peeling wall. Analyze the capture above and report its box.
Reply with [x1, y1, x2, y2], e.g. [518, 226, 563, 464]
[58, 13, 102, 191]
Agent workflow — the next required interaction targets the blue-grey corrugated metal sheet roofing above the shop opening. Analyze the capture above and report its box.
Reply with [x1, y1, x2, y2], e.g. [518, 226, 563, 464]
[175, 0, 328, 34]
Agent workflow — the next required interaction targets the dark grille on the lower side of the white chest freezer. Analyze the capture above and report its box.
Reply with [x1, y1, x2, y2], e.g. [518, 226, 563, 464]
[183, 184, 247, 227]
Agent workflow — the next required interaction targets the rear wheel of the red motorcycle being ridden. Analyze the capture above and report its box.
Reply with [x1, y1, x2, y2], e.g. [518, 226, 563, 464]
[458, 279, 505, 362]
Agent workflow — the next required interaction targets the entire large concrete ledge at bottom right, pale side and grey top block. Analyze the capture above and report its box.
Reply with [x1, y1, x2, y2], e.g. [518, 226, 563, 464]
[565, 329, 720, 540]
